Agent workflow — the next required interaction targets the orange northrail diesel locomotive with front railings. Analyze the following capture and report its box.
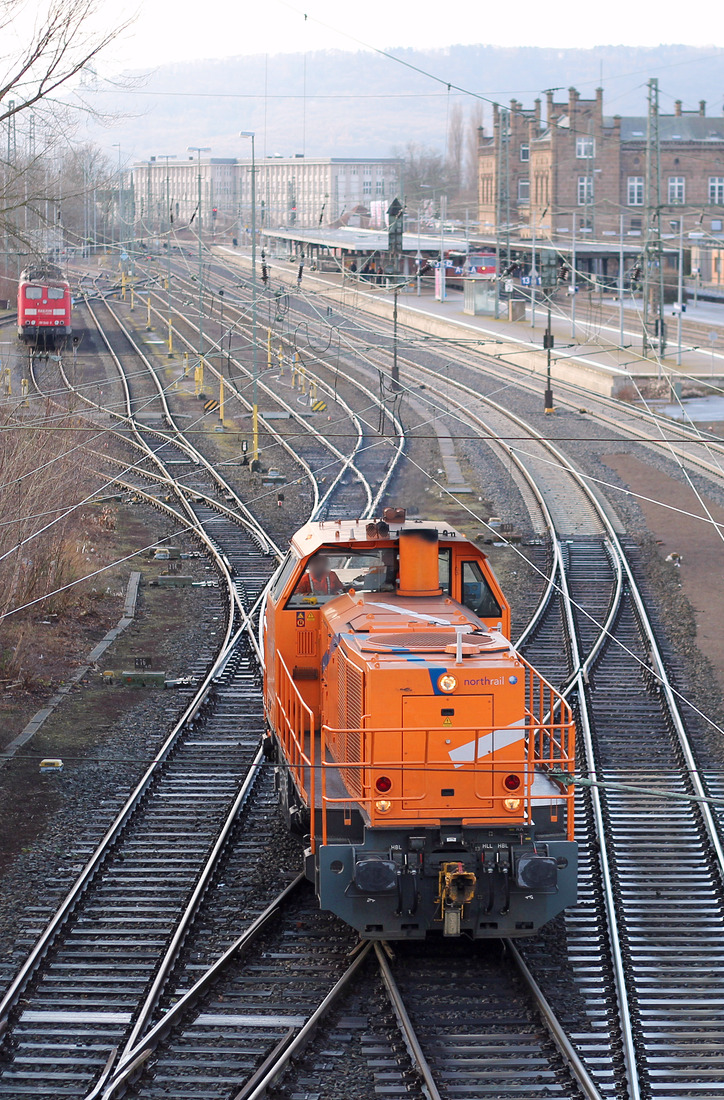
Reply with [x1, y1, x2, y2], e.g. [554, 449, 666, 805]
[264, 509, 577, 939]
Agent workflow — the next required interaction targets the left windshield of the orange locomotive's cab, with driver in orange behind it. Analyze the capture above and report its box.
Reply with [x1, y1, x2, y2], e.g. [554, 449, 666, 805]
[286, 549, 397, 608]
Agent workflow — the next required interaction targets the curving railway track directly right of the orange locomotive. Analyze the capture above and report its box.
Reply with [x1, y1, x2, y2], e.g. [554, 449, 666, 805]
[177, 251, 723, 1097]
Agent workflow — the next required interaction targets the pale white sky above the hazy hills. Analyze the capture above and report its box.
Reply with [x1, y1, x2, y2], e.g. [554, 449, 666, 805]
[99, 0, 722, 72]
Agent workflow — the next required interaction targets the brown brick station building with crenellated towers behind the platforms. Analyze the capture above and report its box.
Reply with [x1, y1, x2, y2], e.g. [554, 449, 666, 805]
[479, 88, 724, 241]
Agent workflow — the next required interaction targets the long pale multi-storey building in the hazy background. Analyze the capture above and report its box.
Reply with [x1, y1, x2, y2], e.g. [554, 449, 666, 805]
[133, 153, 402, 238]
